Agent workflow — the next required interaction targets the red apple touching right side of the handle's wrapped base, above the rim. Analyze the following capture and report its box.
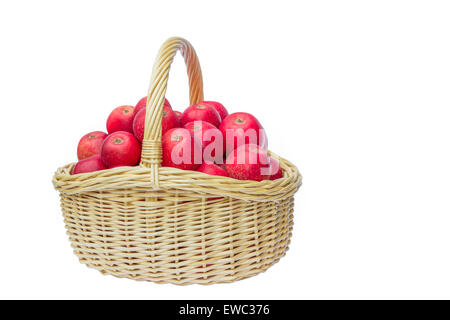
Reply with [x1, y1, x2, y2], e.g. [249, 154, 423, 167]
[161, 128, 202, 170]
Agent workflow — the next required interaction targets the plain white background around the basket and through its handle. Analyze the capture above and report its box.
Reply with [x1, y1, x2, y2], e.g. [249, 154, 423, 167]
[0, 1, 450, 299]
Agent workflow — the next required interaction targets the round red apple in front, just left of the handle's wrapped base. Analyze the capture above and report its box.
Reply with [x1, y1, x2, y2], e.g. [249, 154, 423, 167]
[101, 131, 141, 168]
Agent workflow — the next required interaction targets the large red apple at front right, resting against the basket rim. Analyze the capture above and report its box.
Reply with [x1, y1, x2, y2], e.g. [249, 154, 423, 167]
[225, 144, 269, 181]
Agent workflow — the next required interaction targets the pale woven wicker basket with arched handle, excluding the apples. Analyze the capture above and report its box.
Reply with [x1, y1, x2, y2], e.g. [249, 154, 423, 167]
[53, 38, 301, 284]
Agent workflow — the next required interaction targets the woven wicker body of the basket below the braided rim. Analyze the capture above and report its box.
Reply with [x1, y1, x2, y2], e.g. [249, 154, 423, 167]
[61, 192, 294, 285]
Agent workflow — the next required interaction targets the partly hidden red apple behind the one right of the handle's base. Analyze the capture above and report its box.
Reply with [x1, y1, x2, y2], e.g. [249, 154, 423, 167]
[184, 120, 223, 163]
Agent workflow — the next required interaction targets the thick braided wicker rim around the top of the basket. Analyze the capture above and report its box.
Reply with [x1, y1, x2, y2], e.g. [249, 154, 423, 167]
[52, 151, 302, 202]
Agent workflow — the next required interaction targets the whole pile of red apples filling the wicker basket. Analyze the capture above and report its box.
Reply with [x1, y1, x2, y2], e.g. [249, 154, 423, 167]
[72, 97, 283, 181]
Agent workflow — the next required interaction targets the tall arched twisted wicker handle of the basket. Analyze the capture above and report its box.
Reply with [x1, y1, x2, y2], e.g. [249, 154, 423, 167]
[141, 37, 203, 187]
